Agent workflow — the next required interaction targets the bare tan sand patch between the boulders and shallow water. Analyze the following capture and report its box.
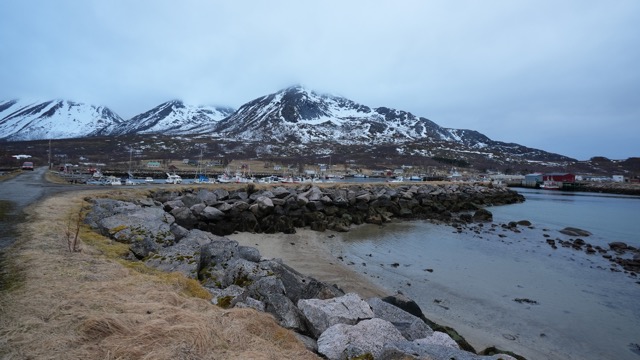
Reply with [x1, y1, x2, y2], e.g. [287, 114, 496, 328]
[228, 229, 391, 298]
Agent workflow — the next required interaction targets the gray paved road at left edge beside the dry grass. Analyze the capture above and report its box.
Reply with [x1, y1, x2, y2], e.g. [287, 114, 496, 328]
[0, 167, 72, 250]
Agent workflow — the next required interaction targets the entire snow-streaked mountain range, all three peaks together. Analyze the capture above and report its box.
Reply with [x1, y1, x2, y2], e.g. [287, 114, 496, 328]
[0, 85, 575, 162]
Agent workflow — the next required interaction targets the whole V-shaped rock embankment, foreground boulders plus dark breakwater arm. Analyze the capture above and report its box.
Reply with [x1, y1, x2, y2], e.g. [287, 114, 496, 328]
[85, 186, 518, 359]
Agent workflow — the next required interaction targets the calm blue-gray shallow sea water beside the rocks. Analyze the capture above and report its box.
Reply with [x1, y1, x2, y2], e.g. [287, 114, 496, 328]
[333, 190, 640, 360]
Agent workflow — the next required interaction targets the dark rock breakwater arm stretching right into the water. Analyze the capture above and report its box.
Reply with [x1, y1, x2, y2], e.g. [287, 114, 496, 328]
[152, 184, 524, 235]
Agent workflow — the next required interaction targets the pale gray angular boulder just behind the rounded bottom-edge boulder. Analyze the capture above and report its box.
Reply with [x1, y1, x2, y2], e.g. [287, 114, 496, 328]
[298, 293, 376, 337]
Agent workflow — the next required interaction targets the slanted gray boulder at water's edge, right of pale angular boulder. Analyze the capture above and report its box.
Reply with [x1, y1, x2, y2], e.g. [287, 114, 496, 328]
[366, 298, 433, 340]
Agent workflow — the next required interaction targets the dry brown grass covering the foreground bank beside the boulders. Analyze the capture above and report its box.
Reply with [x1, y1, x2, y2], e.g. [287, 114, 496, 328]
[0, 193, 317, 359]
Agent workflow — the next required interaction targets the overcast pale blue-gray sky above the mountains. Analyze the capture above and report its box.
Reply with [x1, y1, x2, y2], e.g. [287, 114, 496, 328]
[0, 0, 640, 160]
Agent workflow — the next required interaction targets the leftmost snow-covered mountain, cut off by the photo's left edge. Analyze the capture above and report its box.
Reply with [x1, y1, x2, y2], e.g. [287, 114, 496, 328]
[0, 100, 123, 141]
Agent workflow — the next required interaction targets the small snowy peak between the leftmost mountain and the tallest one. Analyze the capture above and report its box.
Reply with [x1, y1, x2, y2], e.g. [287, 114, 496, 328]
[109, 100, 234, 135]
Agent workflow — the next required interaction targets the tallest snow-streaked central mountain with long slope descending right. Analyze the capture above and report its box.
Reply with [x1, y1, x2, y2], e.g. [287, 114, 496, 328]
[216, 86, 570, 161]
